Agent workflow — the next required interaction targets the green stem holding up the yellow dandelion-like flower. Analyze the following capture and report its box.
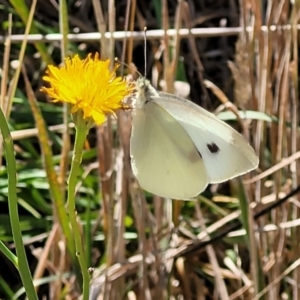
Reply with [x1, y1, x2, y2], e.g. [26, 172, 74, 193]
[67, 118, 90, 300]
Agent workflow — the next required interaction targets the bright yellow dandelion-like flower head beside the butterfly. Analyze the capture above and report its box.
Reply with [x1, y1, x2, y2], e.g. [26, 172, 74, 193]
[41, 53, 133, 125]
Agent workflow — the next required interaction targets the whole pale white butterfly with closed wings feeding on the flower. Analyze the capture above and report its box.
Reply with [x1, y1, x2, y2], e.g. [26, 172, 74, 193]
[130, 77, 258, 199]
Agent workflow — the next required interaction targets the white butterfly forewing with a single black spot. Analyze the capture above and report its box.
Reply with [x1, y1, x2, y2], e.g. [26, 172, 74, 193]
[152, 93, 258, 183]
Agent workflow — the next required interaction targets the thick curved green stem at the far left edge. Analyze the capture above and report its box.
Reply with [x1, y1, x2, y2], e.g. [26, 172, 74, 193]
[0, 109, 38, 300]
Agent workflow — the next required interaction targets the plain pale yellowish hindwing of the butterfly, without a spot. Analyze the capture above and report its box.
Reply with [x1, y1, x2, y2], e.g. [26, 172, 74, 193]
[130, 101, 208, 199]
